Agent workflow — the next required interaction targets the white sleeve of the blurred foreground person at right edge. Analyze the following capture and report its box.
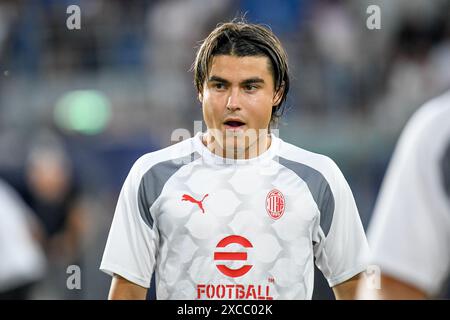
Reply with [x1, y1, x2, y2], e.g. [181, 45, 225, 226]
[369, 109, 450, 296]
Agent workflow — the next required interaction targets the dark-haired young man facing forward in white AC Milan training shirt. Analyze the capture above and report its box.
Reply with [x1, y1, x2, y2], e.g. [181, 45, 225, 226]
[101, 22, 367, 299]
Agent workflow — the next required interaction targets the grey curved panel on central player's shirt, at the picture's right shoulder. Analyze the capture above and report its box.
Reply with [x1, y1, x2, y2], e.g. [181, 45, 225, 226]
[279, 157, 334, 235]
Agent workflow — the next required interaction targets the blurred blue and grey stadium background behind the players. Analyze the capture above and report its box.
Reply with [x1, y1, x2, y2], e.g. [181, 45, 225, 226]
[0, 0, 450, 299]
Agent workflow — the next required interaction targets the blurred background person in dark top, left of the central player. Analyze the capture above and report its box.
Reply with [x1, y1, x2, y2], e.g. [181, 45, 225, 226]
[25, 132, 87, 299]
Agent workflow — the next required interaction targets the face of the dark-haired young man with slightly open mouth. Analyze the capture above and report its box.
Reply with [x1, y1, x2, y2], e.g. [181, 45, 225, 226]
[199, 55, 281, 155]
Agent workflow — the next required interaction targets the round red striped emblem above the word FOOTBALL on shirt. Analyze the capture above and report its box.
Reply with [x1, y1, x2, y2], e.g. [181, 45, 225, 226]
[214, 235, 253, 278]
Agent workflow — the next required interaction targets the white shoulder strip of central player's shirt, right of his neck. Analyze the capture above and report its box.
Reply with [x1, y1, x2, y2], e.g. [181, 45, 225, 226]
[278, 139, 341, 182]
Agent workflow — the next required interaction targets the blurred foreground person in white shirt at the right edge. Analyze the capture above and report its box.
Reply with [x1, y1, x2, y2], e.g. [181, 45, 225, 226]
[358, 91, 450, 299]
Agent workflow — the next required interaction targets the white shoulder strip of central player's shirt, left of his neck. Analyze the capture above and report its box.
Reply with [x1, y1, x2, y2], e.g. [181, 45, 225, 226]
[127, 138, 195, 177]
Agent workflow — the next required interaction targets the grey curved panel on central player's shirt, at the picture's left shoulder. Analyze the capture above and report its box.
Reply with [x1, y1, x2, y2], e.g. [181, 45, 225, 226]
[138, 152, 200, 228]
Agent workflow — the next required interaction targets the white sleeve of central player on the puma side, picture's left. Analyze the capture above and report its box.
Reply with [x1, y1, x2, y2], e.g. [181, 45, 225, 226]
[100, 160, 158, 288]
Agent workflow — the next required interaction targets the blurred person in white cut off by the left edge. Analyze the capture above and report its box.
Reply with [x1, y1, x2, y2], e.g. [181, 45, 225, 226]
[0, 179, 46, 300]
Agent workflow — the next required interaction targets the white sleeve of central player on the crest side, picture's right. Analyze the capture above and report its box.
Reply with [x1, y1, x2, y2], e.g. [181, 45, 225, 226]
[314, 161, 369, 287]
